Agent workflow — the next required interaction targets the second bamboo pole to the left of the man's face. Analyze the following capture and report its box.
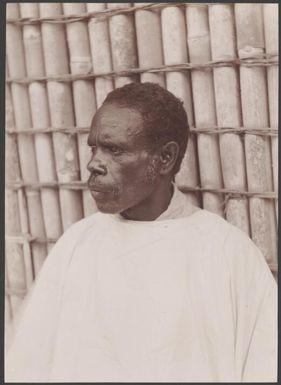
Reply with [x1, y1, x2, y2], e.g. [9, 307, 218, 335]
[39, 3, 83, 230]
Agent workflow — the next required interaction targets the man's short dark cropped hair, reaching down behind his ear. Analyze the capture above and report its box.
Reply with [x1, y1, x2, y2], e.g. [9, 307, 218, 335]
[101, 82, 189, 174]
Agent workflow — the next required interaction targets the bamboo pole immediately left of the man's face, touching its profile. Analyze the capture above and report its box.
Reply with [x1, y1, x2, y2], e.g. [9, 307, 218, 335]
[63, 3, 97, 216]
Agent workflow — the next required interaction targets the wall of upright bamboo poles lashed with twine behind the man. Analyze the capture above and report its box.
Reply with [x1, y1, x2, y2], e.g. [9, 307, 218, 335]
[5, 3, 278, 340]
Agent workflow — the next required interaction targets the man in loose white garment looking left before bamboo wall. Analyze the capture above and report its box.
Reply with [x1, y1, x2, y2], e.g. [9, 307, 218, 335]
[6, 83, 277, 382]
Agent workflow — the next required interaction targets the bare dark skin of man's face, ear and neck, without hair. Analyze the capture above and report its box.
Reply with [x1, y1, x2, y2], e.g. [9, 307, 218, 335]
[88, 103, 179, 221]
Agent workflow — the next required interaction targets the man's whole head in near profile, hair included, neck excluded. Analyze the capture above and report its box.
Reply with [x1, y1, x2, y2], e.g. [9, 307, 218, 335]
[88, 83, 188, 219]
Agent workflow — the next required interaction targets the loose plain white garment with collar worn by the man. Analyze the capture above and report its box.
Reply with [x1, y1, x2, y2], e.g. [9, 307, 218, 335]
[5, 190, 277, 382]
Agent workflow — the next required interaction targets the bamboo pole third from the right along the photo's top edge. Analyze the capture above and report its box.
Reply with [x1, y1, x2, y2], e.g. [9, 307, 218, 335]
[209, 4, 250, 235]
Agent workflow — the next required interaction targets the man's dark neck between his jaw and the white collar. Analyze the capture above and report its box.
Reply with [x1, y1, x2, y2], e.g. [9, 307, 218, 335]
[121, 181, 173, 221]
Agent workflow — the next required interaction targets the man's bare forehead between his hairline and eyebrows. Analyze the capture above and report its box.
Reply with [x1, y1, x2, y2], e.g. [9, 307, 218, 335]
[88, 104, 143, 145]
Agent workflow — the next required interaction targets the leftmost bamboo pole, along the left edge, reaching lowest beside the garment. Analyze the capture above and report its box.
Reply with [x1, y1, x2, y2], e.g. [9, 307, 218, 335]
[5, 82, 26, 317]
